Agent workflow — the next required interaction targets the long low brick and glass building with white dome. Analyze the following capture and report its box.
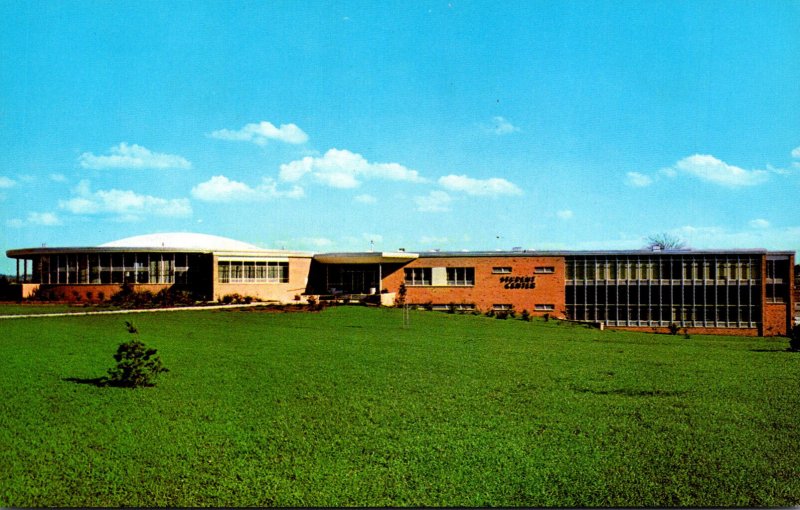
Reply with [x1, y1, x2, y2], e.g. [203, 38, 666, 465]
[7, 234, 795, 336]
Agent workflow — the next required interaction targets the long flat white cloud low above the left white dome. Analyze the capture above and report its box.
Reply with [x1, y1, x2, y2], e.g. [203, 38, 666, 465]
[58, 180, 192, 220]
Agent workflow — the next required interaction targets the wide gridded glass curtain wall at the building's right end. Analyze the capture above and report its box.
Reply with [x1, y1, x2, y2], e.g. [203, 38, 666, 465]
[566, 255, 762, 328]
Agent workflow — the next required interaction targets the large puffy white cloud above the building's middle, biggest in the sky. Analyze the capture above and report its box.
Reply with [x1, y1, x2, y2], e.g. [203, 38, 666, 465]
[279, 149, 424, 188]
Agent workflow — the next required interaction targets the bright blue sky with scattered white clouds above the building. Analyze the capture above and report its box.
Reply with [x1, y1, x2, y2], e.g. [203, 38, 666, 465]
[0, 0, 800, 272]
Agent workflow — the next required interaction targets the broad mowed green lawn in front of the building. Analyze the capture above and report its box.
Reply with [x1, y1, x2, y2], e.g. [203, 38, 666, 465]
[0, 307, 800, 507]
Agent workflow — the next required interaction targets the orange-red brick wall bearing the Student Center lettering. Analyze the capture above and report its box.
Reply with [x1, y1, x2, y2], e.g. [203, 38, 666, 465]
[383, 255, 565, 317]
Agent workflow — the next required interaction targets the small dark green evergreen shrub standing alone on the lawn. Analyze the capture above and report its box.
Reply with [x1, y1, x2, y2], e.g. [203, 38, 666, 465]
[103, 321, 169, 388]
